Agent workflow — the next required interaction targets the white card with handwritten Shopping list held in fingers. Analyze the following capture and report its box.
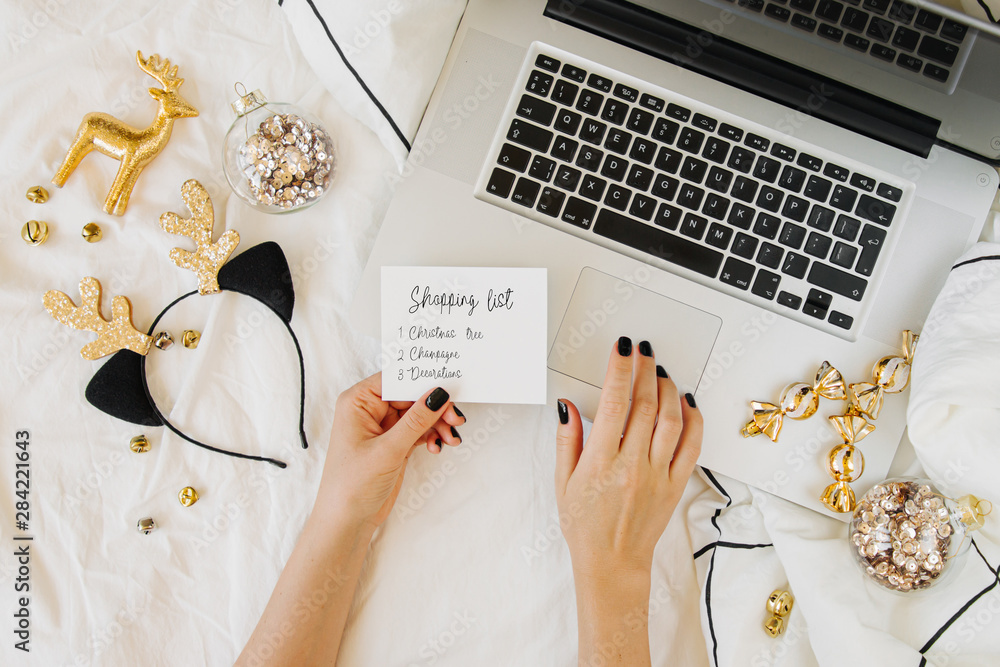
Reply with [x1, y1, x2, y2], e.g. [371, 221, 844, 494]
[382, 266, 547, 404]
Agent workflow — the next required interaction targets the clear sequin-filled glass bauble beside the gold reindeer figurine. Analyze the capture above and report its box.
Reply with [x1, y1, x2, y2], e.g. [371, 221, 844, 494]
[222, 84, 337, 213]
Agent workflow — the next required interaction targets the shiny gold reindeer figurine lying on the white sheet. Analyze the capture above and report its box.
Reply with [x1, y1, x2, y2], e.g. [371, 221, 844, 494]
[52, 51, 198, 215]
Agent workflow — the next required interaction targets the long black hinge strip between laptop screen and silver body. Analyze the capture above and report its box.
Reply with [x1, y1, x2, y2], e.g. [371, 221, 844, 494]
[545, 0, 941, 158]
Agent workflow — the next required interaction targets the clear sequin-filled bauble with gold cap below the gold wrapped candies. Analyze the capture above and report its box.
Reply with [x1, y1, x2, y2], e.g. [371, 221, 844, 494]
[848, 478, 993, 593]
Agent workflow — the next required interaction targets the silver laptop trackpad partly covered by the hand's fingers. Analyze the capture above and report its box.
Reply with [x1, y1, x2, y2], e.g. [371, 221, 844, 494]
[548, 267, 722, 402]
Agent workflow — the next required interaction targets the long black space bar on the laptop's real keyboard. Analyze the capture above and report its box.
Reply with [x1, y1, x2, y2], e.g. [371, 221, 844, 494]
[594, 209, 728, 278]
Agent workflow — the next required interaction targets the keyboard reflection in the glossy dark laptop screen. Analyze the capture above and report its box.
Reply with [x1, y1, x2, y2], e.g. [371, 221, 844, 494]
[712, 0, 973, 92]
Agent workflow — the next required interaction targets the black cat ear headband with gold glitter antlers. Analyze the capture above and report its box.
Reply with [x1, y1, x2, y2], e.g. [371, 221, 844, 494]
[42, 179, 309, 468]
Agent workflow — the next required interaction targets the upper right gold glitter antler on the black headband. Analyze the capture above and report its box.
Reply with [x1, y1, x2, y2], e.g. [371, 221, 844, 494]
[160, 179, 240, 294]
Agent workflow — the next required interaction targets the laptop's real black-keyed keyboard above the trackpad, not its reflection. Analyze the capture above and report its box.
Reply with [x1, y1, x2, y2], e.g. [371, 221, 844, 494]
[476, 44, 913, 339]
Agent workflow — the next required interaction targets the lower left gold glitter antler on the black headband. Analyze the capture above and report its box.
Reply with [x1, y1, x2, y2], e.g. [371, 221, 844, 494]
[42, 278, 153, 361]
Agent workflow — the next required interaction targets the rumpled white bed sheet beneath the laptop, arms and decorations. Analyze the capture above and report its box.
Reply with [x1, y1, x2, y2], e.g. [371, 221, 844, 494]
[0, 0, 1000, 667]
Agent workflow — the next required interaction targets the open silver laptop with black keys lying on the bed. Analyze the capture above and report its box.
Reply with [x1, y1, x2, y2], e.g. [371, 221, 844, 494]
[352, 0, 1000, 519]
